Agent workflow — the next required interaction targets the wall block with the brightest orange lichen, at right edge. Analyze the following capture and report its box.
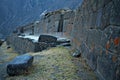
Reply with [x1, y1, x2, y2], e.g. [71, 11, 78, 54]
[104, 26, 120, 55]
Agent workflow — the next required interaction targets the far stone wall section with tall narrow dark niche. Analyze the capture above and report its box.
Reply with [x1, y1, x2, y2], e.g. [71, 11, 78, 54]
[35, 10, 74, 35]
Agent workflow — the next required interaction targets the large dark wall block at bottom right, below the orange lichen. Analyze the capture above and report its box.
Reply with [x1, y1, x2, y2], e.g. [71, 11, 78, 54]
[97, 51, 117, 80]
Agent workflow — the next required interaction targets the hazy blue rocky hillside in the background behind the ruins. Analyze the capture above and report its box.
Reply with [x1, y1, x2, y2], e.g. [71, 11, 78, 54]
[0, 0, 82, 36]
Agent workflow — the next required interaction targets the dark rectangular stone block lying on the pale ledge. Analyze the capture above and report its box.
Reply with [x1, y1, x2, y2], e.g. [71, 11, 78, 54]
[38, 35, 57, 43]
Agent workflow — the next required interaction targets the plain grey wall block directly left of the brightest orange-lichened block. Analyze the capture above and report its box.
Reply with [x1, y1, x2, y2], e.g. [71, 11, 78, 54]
[86, 29, 107, 49]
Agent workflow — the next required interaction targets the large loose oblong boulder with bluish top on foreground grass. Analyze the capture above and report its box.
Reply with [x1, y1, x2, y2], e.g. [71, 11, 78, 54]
[7, 54, 33, 76]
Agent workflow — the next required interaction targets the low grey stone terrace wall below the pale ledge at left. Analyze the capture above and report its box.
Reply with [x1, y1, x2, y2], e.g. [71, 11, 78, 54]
[7, 34, 49, 54]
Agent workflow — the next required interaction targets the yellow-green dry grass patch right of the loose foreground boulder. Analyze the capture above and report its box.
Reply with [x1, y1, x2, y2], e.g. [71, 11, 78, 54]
[6, 47, 80, 80]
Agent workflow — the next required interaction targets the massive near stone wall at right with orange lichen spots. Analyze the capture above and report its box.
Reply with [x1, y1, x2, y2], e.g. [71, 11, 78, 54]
[72, 0, 120, 80]
